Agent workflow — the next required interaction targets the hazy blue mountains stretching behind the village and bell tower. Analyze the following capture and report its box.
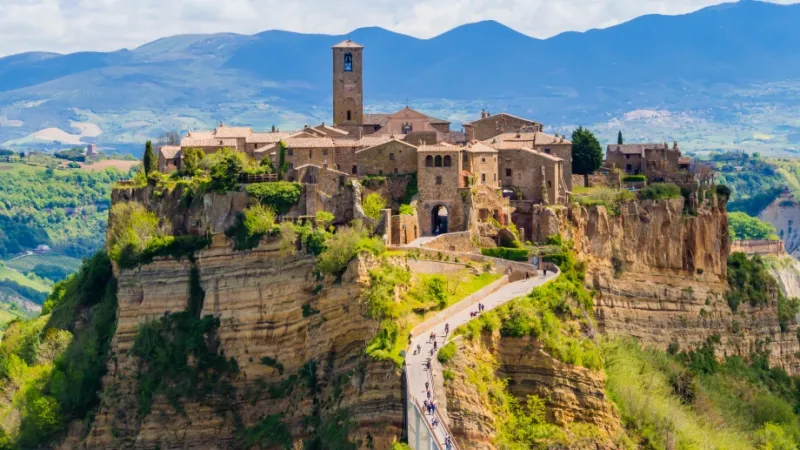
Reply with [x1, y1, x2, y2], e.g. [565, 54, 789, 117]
[0, 1, 800, 154]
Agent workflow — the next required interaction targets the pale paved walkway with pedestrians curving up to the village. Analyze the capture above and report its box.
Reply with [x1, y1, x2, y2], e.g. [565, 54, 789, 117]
[406, 271, 558, 448]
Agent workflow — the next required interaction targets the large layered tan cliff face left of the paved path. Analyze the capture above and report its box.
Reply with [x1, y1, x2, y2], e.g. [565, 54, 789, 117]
[68, 235, 403, 449]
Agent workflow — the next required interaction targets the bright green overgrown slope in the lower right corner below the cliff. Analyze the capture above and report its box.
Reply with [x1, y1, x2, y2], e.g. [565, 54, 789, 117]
[604, 338, 800, 449]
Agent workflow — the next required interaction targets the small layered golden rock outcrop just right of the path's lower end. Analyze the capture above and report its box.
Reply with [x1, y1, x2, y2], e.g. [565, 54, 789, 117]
[445, 332, 622, 450]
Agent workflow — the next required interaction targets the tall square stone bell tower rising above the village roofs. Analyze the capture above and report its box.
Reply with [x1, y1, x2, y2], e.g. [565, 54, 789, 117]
[333, 39, 364, 128]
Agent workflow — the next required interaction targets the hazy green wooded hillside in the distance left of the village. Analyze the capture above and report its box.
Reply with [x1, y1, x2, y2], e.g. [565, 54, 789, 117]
[0, 164, 130, 258]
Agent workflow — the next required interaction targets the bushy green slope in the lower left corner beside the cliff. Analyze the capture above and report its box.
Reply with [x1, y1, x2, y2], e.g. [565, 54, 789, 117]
[0, 253, 117, 448]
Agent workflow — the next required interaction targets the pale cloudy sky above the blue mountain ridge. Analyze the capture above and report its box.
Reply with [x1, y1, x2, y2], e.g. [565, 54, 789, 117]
[0, 0, 800, 56]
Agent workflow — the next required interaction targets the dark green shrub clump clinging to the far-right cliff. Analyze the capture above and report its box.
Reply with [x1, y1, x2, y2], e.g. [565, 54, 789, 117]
[725, 252, 780, 312]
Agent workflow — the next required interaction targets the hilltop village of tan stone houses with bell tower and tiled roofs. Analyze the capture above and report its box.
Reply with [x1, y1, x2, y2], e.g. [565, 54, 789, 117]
[158, 40, 690, 244]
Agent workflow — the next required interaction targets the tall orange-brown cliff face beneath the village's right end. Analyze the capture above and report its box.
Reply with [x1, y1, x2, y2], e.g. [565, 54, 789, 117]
[562, 197, 800, 374]
